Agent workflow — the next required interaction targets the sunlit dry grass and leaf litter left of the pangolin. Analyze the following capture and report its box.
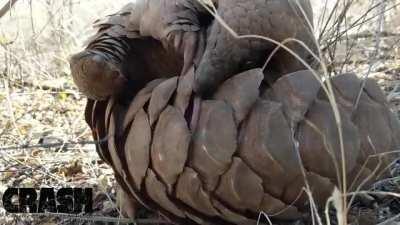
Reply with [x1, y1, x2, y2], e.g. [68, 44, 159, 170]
[0, 0, 126, 224]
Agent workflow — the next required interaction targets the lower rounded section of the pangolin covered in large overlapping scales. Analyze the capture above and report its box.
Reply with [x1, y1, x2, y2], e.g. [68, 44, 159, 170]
[86, 69, 400, 225]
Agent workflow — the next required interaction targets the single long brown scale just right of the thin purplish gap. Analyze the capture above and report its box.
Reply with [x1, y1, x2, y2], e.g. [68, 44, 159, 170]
[190, 100, 237, 191]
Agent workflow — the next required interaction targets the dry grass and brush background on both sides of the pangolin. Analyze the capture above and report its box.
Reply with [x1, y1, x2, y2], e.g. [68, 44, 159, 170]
[0, 0, 400, 224]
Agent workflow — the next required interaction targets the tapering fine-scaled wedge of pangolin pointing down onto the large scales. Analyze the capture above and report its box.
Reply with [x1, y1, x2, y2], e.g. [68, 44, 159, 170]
[195, 0, 316, 94]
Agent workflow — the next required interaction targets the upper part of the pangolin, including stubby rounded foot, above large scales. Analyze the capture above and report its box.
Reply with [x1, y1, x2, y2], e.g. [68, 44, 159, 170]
[70, 0, 315, 99]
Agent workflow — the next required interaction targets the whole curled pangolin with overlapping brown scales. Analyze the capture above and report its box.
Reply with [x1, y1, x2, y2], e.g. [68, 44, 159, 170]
[71, 0, 400, 225]
